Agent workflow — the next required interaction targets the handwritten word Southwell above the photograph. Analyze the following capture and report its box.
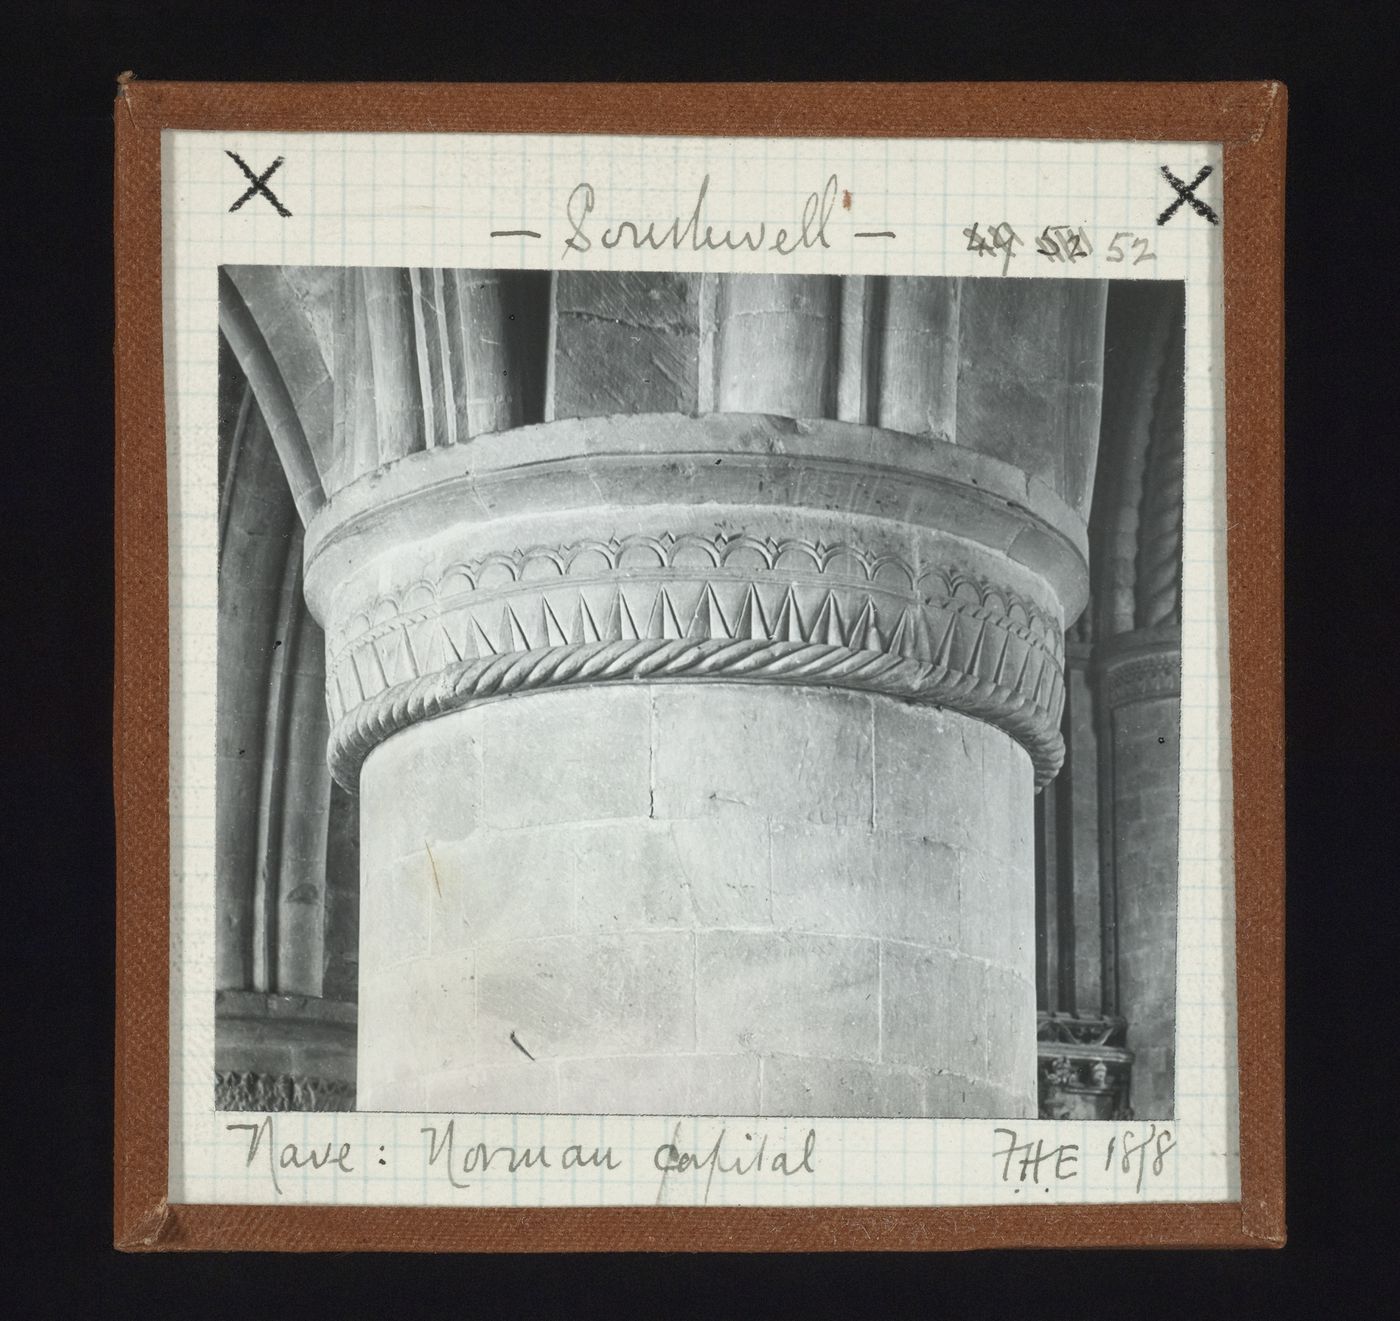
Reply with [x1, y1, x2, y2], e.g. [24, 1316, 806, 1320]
[561, 175, 841, 257]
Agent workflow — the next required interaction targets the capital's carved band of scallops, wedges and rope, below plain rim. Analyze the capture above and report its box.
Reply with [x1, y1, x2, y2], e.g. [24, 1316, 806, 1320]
[326, 536, 1064, 786]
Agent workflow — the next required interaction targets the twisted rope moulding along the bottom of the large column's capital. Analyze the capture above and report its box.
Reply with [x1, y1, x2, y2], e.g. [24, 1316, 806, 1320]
[329, 638, 1064, 791]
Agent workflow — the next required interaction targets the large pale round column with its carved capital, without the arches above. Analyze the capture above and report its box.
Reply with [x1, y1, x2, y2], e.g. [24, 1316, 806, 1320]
[307, 414, 1086, 1117]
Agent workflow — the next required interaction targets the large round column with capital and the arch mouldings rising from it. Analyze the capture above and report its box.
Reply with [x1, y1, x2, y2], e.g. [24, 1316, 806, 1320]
[230, 270, 1105, 1117]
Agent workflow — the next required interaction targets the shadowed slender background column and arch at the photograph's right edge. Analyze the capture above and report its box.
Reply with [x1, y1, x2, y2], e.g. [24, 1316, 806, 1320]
[1095, 283, 1186, 1119]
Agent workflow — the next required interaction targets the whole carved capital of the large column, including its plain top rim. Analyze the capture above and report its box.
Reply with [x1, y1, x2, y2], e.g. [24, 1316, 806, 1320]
[307, 416, 1082, 786]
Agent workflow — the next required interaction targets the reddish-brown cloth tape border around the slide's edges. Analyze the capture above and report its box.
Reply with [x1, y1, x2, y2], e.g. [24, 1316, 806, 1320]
[113, 76, 1287, 1251]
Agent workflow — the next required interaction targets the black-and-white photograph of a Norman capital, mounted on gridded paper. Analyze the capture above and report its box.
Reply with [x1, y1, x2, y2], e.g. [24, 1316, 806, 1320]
[210, 264, 1186, 1121]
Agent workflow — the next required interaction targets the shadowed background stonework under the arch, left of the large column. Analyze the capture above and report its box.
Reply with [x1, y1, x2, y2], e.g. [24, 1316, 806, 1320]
[214, 333, 356, 1110]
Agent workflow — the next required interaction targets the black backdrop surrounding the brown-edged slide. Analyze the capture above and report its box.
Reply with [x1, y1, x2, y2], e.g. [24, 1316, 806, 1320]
[8, 0, 1400, 1318]
